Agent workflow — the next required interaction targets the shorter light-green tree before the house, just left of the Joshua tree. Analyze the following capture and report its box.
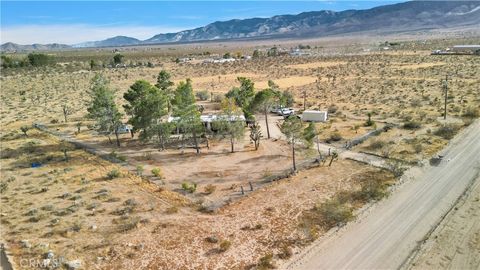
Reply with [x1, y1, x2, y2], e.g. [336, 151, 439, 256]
[214, 98, 245, 153]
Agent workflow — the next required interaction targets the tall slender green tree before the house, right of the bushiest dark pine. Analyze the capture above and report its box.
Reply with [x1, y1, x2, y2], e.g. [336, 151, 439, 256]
[173, 79, 203, 154]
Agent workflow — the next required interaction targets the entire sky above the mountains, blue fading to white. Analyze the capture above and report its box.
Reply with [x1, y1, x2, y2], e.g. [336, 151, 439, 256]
[0, 0, 403, 44]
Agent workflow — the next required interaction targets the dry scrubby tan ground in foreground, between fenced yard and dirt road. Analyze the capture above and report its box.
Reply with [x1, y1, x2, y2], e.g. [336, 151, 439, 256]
[1, 123, 391, 269]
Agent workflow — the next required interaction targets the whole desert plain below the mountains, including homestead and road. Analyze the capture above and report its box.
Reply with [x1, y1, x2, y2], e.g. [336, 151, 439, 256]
[0, 1, 480, 269]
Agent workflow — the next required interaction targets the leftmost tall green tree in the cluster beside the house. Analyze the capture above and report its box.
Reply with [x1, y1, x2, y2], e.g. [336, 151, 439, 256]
[87, 74, 123, 146]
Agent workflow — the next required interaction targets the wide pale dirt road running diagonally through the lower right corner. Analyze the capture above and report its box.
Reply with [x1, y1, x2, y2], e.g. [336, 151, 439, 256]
[284, 120, 480, 269]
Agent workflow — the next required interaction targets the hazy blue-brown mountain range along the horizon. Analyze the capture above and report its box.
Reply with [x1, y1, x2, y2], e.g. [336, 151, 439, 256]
[1, 1, 480, 51]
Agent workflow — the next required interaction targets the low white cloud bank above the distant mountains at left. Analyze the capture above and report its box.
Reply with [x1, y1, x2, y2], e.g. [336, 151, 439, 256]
[0, 24, 190, 44]
